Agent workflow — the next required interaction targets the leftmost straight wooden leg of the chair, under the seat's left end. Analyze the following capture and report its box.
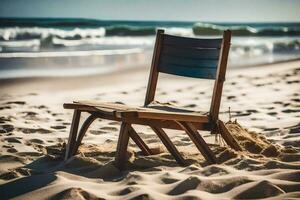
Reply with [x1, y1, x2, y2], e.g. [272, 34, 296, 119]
[65, 109, 81, 160]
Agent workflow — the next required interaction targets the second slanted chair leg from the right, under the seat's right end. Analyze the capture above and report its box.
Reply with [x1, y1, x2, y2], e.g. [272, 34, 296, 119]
[178, 122, 217, 163]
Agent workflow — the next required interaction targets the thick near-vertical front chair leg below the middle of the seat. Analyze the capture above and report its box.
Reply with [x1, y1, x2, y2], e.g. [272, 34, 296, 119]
[115, 122, 130, 170]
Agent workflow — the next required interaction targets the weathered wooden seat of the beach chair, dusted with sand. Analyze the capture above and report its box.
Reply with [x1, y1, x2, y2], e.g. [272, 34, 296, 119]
[64, 101, 209, 122]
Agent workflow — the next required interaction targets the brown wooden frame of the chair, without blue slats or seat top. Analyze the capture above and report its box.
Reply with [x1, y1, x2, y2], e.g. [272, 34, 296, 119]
[64, 30, 242, 169]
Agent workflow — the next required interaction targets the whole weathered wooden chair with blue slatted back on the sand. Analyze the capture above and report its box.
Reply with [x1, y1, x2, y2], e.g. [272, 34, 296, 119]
[64, 30, 241, 169]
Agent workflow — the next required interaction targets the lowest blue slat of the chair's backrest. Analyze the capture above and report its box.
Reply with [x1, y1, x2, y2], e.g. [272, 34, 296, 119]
[159, 63, 216, 79]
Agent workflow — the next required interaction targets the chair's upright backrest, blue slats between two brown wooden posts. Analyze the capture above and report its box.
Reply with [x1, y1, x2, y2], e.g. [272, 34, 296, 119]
[145, 30, 231, 120]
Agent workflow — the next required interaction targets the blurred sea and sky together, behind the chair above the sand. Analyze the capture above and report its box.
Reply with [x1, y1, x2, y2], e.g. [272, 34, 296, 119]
[0, 0, 300, 81]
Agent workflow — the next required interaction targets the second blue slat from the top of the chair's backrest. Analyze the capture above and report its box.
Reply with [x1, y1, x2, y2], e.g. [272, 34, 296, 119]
[162, 46, 220, 60]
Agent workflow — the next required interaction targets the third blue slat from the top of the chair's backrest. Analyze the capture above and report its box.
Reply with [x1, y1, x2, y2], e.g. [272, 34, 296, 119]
[158, 55, 218, 68]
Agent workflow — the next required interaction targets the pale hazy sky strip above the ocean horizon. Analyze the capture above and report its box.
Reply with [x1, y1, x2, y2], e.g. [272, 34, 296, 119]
[0, 0, 300, 22]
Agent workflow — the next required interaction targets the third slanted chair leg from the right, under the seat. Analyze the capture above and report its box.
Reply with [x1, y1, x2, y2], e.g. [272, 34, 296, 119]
[151, 126, 186, 165]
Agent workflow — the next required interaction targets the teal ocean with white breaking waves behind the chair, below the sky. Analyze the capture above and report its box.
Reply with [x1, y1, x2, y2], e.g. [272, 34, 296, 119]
[0, 18, 300, 79]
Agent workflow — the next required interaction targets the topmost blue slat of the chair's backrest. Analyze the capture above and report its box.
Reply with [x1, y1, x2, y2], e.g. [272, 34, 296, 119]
[163, 34, 222, 48]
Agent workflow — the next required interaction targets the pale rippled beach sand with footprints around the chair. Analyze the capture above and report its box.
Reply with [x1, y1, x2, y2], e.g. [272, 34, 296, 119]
[0, 61, 300, 199]
